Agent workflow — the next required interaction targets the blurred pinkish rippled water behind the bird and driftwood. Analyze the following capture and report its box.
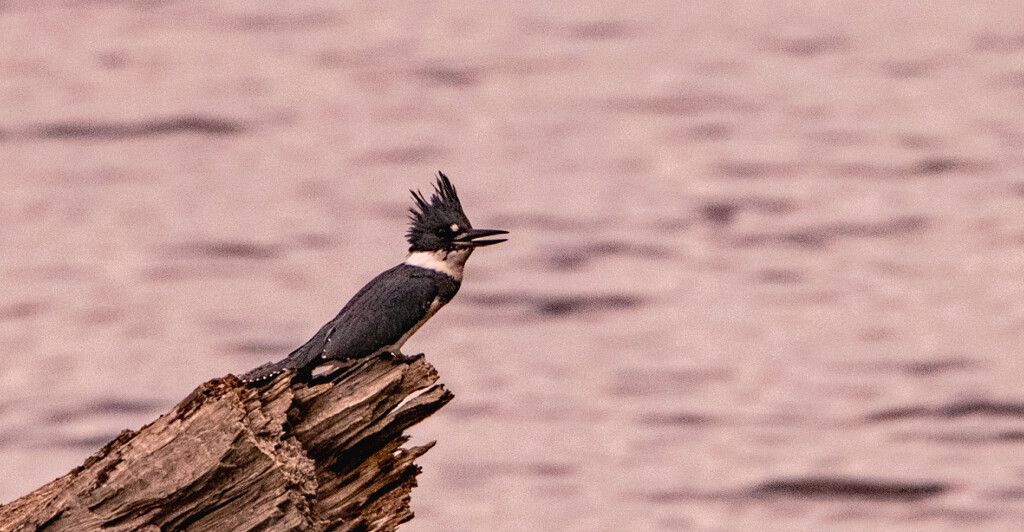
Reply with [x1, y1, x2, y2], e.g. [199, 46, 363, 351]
[0, 0, 1024, 532]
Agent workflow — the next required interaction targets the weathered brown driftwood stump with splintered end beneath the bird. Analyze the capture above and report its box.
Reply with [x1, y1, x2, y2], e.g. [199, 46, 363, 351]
[0, 358, 453, 532]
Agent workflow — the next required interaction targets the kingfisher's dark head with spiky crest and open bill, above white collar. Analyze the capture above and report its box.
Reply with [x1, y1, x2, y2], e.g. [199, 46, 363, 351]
[406, 172, 508, 255]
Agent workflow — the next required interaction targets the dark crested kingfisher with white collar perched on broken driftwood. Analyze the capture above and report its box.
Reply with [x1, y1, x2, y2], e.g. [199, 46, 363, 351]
[241, 172, 508, 387]
